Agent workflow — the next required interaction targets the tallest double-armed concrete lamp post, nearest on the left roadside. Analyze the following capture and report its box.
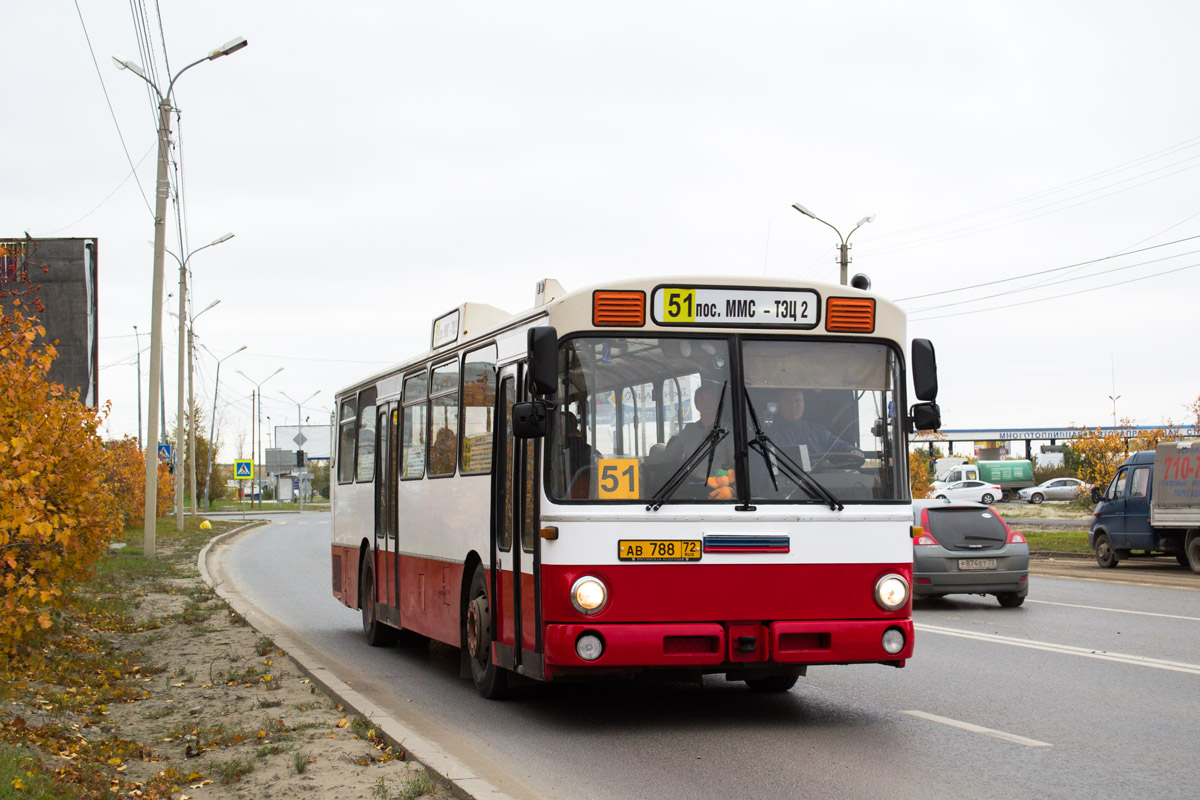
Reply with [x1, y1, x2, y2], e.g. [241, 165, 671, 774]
[113, 37, 247, 559]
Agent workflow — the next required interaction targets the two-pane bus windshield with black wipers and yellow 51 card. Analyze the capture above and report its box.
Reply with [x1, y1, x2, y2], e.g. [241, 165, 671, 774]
[546, 336, 907, 507]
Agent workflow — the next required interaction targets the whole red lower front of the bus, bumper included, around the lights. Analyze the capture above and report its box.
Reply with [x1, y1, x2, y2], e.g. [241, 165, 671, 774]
[542, 564, 913, 668]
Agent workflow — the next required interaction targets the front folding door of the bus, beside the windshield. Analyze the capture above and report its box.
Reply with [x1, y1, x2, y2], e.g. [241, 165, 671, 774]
[492, 367, 544, 678]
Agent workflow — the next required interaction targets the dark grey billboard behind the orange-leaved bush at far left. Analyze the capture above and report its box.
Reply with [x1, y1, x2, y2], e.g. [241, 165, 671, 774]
[0, 236, 100, 407]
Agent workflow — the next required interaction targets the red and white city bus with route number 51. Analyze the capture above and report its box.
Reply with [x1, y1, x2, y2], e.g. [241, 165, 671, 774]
[330, 277, 940, 697]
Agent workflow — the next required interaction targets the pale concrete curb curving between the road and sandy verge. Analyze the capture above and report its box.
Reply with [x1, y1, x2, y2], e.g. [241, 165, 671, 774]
[197, 519, 515, 800]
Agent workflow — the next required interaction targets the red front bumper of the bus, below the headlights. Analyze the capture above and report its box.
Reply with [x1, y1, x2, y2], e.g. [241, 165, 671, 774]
[545, 618, 913, 669]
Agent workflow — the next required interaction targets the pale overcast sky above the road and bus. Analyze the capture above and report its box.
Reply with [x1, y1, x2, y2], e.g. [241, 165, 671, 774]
[0, 0, 1200, 458]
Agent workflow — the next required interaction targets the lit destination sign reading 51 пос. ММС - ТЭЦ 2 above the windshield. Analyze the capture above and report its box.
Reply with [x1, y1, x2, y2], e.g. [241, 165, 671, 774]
[650, 287, 821, 329]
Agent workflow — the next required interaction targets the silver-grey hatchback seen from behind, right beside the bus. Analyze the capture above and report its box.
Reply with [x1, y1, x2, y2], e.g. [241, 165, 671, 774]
[912, 500, 1030, 608]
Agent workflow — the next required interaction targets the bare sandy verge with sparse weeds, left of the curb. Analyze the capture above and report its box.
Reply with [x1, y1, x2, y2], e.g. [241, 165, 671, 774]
[97, 527, 452, 800]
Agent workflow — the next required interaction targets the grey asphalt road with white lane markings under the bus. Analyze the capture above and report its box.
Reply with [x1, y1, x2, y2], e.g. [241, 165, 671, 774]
[215, 513, 1200, 800]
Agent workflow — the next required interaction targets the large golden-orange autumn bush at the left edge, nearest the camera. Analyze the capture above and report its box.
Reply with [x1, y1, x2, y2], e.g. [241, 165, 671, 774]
[0, 297, 121, 656]
